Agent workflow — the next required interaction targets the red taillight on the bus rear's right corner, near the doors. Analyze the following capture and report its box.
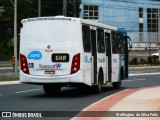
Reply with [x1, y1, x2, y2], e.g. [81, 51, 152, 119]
[71, 53, 80, 74]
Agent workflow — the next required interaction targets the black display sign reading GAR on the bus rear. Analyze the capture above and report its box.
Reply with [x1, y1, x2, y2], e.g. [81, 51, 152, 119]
[52, 53, 69, 62]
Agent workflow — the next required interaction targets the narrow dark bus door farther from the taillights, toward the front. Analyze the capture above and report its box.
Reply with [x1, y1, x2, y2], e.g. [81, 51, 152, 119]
[105, 32, 112, 82]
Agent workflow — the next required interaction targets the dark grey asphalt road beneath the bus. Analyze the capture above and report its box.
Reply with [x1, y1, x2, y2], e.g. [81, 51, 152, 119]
[0, 74, 160, 120]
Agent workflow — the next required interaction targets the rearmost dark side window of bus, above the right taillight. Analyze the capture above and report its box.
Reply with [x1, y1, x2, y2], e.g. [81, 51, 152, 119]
[82, 25, 91, 52]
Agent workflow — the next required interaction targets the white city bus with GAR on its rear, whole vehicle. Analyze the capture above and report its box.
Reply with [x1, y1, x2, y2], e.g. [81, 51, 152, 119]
[20, 16, 131, 94]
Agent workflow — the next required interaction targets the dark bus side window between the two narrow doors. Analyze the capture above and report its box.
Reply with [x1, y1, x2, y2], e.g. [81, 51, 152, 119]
[97, 28, 105, 53]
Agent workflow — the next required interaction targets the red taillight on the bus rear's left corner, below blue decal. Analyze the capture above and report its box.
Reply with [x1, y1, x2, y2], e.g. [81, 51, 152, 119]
[20, 54, 29, 74]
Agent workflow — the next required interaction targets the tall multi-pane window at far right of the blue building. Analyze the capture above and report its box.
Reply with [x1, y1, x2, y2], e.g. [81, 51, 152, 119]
[147, 8, 158, 32]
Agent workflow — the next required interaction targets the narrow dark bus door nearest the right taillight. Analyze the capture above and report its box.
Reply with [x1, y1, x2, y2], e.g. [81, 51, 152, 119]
[91, 27, 97, 84]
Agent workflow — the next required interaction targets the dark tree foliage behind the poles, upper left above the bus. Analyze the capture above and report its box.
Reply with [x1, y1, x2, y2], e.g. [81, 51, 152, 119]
[0, 0, 81, 60]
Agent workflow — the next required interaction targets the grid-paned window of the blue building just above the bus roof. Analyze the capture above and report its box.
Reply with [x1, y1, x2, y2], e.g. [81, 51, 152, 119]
[83, 5, 98, 19]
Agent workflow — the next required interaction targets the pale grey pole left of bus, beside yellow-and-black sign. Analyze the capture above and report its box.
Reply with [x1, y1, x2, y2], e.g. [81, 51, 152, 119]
[14, 0, 18, 72]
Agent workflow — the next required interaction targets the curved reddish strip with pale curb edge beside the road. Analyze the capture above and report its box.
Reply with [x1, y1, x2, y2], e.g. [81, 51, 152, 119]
[71, 89, 139, 120]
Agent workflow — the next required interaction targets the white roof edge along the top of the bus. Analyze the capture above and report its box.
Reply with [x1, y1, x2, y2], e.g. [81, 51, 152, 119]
[21, 16, 117, 31]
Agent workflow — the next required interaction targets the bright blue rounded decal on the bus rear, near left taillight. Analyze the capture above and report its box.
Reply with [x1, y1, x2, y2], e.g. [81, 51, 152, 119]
[28, 51, 42, 60]
